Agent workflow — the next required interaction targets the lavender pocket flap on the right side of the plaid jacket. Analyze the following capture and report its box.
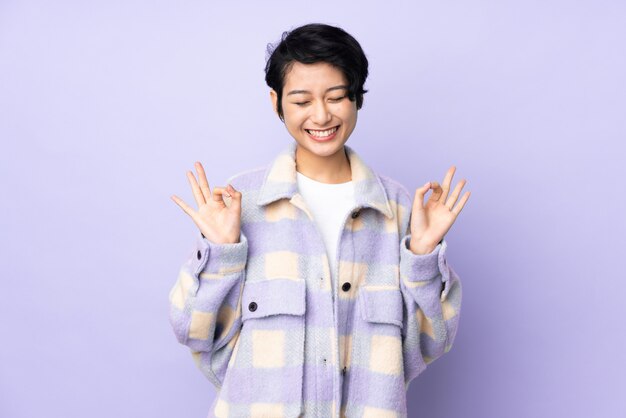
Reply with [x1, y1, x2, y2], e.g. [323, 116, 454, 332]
[359, 286, 404, 327]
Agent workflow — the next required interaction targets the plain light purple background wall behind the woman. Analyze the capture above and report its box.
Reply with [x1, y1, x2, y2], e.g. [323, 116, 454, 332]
[0, 0, 626, 418]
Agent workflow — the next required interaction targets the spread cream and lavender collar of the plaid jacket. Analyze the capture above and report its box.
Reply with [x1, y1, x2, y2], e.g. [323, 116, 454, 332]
[257, 141, 393, 218]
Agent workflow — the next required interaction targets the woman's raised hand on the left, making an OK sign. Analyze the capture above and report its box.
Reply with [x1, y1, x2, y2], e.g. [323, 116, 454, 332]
[171, 162, 241, 244]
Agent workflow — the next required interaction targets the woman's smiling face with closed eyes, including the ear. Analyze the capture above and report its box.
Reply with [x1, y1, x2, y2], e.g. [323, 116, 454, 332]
[270, 61, 357, 157]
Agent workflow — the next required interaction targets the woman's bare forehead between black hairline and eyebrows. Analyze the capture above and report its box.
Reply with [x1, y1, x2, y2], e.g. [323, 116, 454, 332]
[284, 61, 347, 90]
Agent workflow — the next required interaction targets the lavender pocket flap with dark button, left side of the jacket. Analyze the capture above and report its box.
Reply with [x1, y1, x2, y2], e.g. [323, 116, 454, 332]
[241, 278, 306, 321]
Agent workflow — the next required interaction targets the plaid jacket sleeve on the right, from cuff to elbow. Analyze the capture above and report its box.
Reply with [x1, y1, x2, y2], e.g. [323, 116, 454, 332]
[400, 220, 461, 388]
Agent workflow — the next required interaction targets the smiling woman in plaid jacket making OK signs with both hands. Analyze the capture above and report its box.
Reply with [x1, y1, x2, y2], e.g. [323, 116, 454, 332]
[169, 24, 469, 418]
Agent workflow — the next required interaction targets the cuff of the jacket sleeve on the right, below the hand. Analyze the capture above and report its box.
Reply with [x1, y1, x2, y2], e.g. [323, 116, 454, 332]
[400, 234, 450, 282]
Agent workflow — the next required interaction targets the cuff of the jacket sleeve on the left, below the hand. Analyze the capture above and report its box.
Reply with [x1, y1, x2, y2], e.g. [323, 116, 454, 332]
[192, 231, 248, 275]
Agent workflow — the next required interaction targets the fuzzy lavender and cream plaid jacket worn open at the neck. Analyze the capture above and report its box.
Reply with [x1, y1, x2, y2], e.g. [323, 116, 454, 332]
[169, 142, 461, 418]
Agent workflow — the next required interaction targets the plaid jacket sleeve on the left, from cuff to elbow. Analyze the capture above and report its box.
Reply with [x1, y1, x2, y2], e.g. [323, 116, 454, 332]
[169, 231, 248, 388]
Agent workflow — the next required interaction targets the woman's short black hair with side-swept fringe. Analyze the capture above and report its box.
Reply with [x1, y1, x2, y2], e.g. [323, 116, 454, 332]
[265, 23, 368, 122]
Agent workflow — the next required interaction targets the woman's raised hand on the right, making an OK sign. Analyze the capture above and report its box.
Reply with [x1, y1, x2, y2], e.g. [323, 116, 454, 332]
[409, 166, 470, 254]
